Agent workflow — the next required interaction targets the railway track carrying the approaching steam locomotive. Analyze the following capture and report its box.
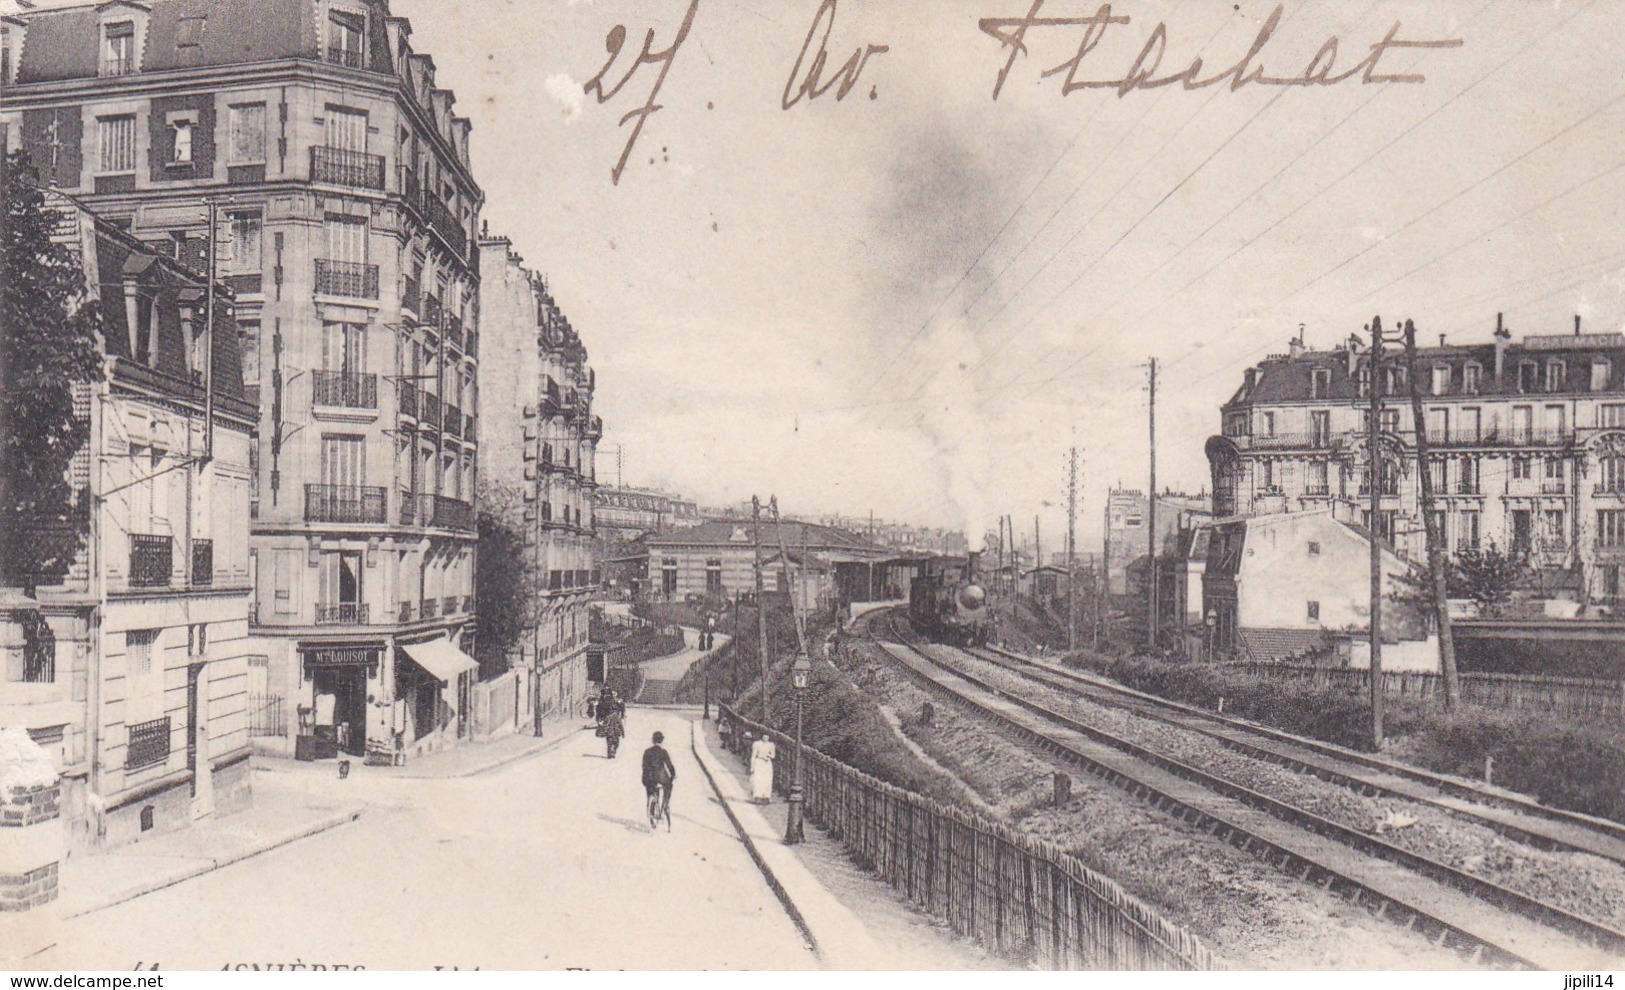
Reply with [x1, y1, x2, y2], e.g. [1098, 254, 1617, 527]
[869, 604, 1625, 969]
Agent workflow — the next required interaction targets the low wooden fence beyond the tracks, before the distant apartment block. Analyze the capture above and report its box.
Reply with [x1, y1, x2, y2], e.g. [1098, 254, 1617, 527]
[1225, 663, 1625, 715]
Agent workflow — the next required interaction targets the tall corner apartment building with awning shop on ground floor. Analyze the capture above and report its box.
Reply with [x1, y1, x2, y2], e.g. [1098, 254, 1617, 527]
[0, 0, 481, 754]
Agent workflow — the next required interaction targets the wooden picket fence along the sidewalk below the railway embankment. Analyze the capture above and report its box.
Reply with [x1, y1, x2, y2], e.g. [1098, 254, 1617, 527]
[720, 706, 1219, 970]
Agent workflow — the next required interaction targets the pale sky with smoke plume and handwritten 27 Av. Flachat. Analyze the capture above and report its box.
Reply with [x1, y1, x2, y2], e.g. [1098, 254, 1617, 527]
[392, 0, 1625, 549]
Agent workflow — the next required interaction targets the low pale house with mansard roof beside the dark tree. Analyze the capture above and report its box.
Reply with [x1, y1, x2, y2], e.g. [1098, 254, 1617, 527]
[0, 195, 254, 847]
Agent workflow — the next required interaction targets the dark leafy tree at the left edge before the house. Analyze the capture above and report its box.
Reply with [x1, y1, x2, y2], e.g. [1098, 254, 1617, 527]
[0, 151, 102, 593]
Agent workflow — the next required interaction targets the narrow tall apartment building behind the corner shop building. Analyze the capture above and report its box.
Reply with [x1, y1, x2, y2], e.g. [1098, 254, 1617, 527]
[478, 230, 603, 727]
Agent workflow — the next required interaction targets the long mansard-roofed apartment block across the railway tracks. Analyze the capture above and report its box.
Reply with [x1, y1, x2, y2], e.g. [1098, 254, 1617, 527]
[1207, 319, 1625, 608]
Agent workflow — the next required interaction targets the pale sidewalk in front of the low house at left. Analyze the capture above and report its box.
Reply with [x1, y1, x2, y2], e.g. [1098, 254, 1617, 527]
[55, 771, 364, 920]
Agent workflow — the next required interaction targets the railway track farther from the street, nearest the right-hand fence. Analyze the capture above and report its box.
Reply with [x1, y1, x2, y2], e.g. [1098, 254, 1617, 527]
[965, 647, 1625, 863]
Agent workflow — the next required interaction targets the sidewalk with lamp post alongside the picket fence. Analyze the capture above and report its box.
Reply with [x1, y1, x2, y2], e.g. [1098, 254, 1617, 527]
[694, 722, 1009, 970]
